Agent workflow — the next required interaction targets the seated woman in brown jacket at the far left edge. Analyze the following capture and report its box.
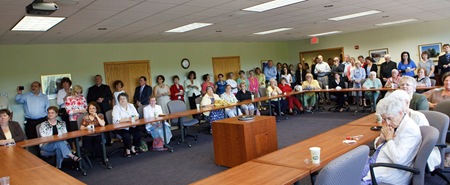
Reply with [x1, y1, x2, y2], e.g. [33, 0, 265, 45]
[0, 109, 25, 146]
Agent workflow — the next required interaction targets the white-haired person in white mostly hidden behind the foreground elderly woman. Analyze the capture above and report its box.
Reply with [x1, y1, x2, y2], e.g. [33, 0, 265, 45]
[386, 89, 441, 171]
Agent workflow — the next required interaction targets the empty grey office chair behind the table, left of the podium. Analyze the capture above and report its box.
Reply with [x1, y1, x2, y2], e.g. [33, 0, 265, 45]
[167, 100, 199, 147]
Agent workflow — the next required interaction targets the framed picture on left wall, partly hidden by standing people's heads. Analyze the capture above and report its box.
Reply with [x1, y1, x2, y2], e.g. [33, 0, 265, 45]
[41, 74, 71, 99]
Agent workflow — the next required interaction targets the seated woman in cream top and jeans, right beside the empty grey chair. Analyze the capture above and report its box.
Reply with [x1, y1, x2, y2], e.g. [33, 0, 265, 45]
[200, 86, 225, 134]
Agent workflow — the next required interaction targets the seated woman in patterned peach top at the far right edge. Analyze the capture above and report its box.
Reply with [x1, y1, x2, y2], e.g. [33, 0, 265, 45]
[423, 72, 450, 109]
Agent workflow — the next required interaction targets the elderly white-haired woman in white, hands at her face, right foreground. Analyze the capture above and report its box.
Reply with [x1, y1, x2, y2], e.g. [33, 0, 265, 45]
[361, 97, 422, 184]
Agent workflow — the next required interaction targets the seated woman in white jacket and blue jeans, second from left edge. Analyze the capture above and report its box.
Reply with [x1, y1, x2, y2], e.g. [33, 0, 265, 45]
[39, 106, 81, 169]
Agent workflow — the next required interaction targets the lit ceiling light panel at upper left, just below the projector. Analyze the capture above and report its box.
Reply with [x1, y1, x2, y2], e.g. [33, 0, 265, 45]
[11, 16, 65, 31]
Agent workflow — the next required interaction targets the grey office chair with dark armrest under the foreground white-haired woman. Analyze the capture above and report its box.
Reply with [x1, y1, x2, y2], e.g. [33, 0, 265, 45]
[370, 126, 439, 185]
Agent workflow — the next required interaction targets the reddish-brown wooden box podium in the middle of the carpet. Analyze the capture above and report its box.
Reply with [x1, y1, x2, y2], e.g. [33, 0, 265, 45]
[212, 116, 278, 167]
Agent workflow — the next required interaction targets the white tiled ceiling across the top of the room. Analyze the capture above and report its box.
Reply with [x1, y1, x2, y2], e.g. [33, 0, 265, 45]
[0, 0, 450, 44]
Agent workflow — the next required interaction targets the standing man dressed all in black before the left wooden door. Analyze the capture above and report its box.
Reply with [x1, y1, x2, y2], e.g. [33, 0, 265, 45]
[86, 75, 112, 115]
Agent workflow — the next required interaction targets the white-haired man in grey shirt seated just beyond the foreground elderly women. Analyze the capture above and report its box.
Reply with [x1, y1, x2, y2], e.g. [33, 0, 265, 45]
[399, 76, 429, 110]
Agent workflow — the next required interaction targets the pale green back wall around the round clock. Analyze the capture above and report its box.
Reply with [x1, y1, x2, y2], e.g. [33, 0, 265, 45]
[0, 42, 290, 122]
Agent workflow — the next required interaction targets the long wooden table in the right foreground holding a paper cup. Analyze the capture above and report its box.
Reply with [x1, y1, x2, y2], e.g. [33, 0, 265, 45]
[193, 114, 380, 185]
